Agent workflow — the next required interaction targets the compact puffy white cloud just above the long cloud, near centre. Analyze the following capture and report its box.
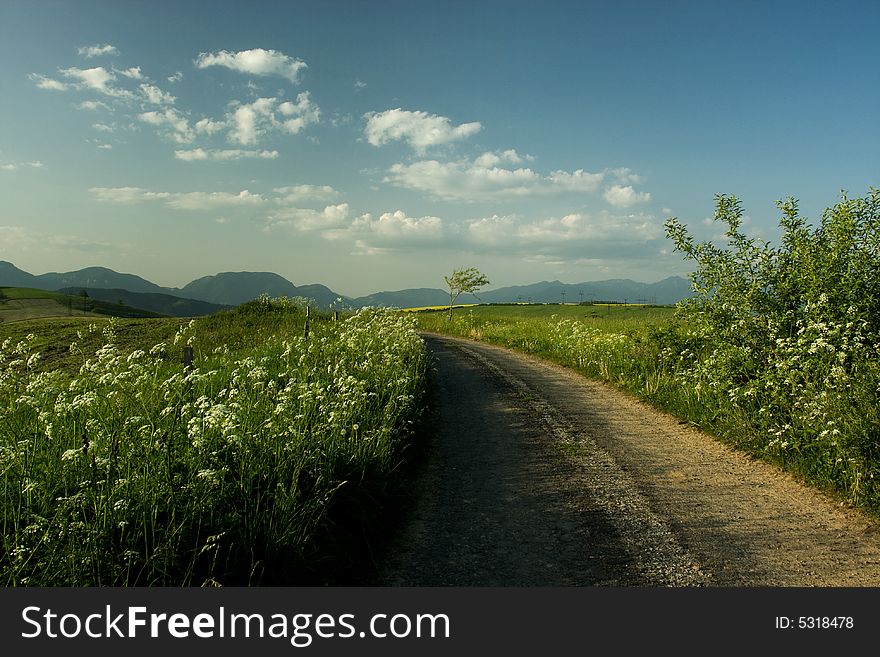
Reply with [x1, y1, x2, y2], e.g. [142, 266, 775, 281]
[364, 108, 483, 153]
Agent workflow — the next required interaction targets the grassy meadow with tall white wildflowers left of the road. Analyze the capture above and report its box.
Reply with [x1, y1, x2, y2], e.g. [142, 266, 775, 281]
[0, 300, 425, 586]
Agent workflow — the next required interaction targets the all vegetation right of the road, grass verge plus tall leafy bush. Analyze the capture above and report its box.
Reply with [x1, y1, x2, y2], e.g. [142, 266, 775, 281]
[416, 189, 880, 513]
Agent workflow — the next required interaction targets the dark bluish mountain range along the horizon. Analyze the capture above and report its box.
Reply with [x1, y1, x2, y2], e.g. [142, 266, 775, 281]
[0, 260, 691, 316]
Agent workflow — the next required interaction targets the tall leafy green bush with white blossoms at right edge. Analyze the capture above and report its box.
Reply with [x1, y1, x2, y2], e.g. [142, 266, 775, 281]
[666, 189, 880, 506]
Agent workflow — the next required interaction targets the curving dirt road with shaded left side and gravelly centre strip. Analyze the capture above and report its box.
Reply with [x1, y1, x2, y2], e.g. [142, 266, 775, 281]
[379, 336, 880, 586]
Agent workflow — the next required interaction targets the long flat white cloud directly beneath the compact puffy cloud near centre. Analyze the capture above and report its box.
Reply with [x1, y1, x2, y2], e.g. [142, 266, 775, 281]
[385, 150, 606, 201]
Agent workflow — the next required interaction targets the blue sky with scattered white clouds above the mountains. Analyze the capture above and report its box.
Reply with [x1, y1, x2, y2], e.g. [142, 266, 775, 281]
[0, 0, 880, 296]
